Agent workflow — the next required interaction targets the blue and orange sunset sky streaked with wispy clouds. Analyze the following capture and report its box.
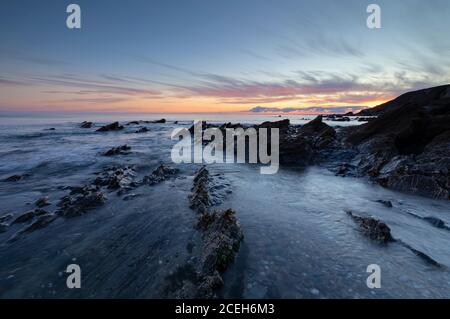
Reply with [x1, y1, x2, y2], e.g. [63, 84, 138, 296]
[0, 0, 450, 112]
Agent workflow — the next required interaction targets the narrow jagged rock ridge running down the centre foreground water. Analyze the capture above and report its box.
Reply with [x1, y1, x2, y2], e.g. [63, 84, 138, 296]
[165, 167, 244, 299]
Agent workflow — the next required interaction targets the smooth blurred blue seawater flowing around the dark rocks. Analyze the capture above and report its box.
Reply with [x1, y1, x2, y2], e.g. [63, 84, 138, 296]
[0, 115, 450, 298]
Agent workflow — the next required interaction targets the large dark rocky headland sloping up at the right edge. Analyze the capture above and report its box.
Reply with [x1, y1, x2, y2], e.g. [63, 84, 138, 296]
[344, 85, 450, 199]
